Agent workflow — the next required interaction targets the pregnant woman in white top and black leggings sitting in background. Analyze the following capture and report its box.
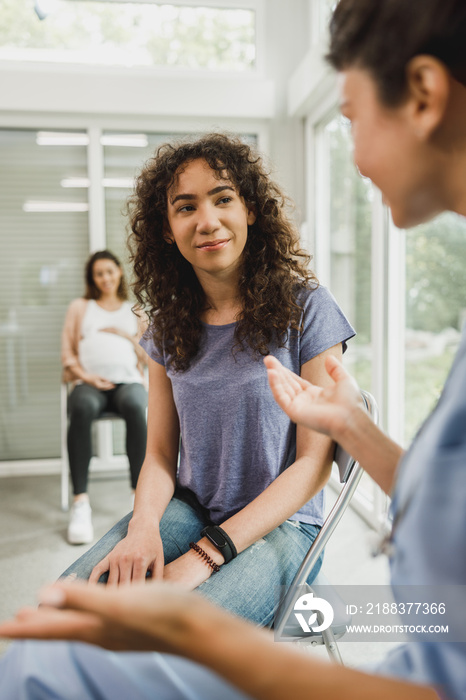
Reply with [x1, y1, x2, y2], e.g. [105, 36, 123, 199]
[62, 250, 147, 544]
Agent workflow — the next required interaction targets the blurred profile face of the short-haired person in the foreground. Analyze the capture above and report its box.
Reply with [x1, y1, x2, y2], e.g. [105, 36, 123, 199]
[340, 68, 444, 228]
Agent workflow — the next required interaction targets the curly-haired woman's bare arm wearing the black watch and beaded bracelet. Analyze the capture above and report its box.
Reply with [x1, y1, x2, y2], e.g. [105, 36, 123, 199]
[164, 344, 342, 589]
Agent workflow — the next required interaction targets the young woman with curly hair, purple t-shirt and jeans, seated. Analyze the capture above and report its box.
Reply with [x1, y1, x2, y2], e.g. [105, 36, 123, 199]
[61, 134, 354, 626]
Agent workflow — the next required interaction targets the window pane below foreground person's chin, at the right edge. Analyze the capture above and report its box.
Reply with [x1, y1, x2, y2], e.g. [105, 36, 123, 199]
[404, 214, 466, 444]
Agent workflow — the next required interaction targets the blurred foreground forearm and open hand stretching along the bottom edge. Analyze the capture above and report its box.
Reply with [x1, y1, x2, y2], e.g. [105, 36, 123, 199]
[0, 583, 438, 700]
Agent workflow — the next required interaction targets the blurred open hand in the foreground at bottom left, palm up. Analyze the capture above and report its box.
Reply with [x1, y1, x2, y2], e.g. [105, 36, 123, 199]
[0, 582, 198, 652]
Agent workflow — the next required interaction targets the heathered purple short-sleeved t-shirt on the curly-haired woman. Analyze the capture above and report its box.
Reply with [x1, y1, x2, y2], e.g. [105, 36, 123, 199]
[141, 287, 355, 525]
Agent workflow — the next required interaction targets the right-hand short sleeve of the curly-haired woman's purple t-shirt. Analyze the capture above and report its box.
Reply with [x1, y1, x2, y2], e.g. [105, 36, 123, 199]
[299, 286, 356, 366]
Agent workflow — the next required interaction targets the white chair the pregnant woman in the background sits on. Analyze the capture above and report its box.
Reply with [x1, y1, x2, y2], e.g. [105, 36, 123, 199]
[60, 383, 128, 511]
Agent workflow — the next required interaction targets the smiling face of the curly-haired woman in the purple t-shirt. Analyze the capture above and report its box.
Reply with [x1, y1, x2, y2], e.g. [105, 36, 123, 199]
[166, 159, 256, 281]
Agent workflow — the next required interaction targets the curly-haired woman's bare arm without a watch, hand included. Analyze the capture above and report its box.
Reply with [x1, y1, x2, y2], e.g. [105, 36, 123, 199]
[89, 359, 179, 584]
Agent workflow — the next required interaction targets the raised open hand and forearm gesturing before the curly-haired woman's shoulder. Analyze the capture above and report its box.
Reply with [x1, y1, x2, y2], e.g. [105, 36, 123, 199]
[264, 356, 403, 494]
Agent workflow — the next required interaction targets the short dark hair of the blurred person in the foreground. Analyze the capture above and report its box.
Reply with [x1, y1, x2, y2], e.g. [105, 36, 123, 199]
[326, 0, 466, 106]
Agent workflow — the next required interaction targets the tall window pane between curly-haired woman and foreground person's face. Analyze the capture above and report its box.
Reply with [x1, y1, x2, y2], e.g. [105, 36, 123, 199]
[313, 111, 387, 528]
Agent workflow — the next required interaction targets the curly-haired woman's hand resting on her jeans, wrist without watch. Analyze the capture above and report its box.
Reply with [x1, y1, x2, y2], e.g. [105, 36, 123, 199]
[89, 523, 164, 586]
